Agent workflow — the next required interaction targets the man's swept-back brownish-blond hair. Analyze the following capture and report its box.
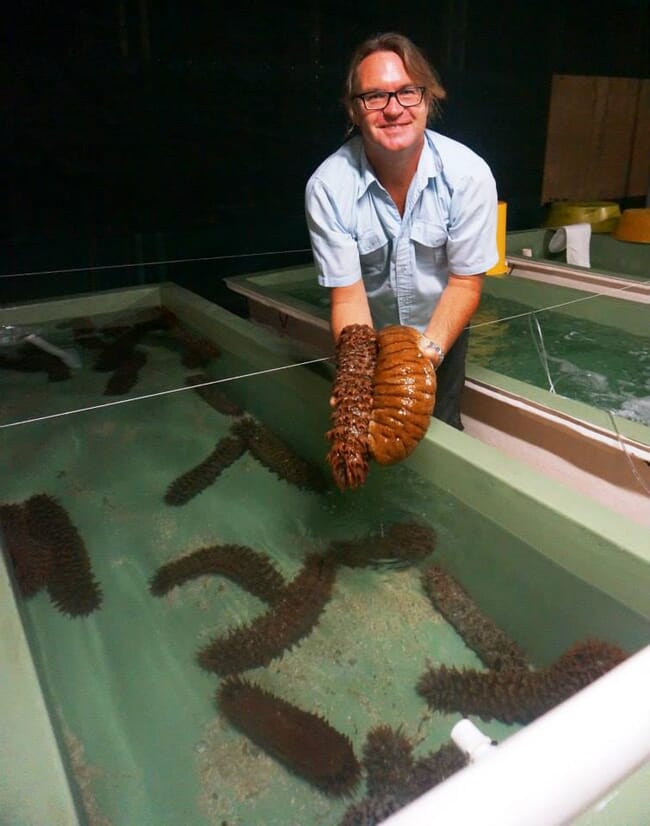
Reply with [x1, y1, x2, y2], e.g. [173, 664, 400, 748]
[342, 32, 447, 134]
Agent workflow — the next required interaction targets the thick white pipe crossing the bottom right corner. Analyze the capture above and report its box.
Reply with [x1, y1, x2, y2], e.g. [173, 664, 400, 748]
[384, 646, 650, 826]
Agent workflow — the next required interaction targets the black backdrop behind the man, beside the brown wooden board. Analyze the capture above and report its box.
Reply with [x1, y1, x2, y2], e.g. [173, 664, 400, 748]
[0, 0, 650, 301]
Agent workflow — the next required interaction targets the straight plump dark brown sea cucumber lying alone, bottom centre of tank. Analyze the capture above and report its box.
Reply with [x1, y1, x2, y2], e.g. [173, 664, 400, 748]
[217, 677, 361, 797]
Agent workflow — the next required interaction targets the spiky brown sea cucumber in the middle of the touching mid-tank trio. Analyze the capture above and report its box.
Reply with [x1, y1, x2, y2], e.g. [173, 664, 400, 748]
[197, 554, 337, 676]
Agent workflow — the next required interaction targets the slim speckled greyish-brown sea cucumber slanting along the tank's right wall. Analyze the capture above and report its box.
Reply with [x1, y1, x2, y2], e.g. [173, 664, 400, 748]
[422, 565, 530, 670]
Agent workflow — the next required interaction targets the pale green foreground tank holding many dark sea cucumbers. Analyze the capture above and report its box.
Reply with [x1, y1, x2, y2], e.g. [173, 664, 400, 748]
[0, 283, 650, 826]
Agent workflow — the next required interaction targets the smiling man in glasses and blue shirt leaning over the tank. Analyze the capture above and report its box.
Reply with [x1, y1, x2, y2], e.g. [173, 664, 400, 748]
[305, 33, 498, 430]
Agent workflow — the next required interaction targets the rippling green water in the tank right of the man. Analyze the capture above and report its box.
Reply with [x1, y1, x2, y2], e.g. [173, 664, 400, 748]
[469, 294, 650, 424]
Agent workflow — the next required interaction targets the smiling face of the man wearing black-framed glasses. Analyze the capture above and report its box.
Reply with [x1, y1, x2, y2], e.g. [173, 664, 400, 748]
[355, 52, 427, 154]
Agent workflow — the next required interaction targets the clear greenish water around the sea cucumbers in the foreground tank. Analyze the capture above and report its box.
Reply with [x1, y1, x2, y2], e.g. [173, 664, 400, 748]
[0, 310, 648, 826]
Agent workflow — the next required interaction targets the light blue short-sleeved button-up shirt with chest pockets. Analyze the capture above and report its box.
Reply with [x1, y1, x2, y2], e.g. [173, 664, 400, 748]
[305, 129, 499, 330]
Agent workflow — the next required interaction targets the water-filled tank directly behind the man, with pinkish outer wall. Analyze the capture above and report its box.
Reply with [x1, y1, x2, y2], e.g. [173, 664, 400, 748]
[227, 258, 650, 527]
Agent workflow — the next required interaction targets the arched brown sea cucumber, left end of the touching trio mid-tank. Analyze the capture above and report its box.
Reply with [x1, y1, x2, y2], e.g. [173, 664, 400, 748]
[149, 545, 286, 605]
